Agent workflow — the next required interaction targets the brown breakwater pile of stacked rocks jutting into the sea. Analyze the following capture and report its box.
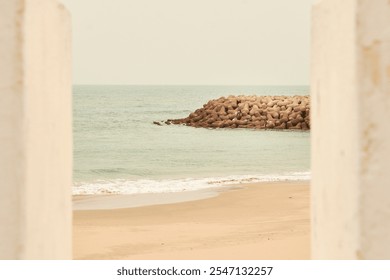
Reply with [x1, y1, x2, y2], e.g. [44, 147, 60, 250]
[155, 95, 310, 130]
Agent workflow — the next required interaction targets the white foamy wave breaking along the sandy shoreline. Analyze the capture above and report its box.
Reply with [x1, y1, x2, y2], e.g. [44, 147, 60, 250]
[73, 172, 310, 195]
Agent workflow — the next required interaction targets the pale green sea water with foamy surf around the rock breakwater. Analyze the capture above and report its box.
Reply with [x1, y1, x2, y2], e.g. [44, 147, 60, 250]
[73, 85, 310, 194]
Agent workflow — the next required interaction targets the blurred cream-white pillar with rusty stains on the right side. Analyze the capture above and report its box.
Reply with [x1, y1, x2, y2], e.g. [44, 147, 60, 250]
[311, 0, 390, 259]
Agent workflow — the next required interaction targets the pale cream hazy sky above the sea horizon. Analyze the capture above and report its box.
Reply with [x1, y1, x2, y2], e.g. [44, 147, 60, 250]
[61, 0, 316, 85]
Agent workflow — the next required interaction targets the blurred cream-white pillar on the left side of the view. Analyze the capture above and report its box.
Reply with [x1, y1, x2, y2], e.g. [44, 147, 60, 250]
[0, 0, 72, 259]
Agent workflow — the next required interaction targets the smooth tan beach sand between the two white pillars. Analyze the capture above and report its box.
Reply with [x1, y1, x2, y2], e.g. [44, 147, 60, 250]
[73, 182, 310, 260]
